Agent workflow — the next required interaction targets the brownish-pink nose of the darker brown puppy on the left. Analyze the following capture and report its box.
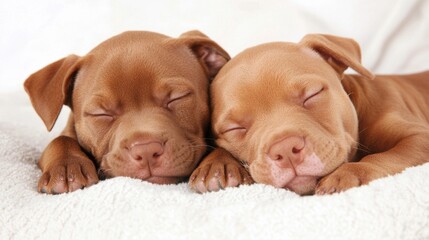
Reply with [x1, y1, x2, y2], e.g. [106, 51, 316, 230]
[129, 142, 164, 162]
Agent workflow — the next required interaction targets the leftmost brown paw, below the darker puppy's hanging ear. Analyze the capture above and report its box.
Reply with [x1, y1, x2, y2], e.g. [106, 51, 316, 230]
[38, 157, 98, 194]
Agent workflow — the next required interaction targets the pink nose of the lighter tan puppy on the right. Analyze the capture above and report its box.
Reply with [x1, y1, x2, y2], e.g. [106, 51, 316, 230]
[267, 136, 305, 164]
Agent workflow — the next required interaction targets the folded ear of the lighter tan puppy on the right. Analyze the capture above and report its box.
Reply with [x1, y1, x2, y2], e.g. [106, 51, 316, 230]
[299, 34, 374, 79]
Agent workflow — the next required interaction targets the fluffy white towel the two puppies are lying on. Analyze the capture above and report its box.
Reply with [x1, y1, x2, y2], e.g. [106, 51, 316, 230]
[0, 121, 429, 239]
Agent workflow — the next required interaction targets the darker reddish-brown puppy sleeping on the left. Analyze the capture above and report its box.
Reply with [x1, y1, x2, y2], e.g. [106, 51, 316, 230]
[25, 31, 229, 193]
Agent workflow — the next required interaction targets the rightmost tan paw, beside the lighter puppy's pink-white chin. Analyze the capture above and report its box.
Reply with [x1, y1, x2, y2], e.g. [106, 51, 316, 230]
[315, 162, 385, 195]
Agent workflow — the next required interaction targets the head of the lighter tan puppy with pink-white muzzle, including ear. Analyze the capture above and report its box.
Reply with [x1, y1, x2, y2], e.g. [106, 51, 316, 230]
[211, 35, 372, 194]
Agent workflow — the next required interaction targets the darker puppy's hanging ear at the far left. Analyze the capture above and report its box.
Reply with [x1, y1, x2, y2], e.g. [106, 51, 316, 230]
[24, 55, 79, 131]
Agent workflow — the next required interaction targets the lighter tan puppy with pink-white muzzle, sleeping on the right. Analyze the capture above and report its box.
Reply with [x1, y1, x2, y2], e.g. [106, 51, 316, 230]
[190, 35, 429, 194]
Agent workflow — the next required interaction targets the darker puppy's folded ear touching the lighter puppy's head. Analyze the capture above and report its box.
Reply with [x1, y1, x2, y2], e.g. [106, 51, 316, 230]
[177, 30, 231, 80]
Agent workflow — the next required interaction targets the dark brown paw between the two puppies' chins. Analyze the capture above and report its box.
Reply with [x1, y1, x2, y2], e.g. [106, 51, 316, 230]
[189, 149, 254, 193]
